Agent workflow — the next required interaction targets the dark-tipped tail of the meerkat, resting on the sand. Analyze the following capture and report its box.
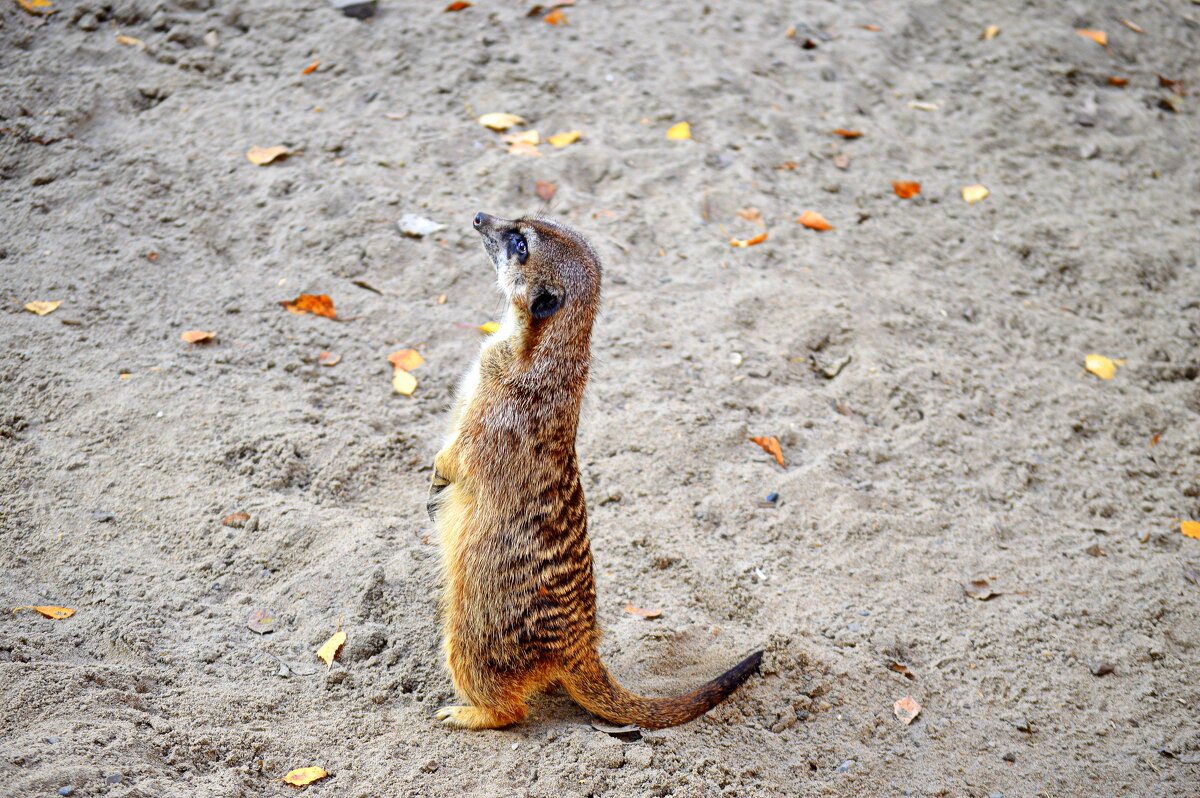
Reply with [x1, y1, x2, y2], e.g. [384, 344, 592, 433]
[559, 652, 762, 728]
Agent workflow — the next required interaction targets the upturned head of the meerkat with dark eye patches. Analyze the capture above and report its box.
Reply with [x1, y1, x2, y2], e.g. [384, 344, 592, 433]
[473, 214, 600, 328]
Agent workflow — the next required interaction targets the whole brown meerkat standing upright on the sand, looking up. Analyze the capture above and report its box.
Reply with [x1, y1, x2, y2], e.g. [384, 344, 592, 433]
[427, 214, 762, 728]
